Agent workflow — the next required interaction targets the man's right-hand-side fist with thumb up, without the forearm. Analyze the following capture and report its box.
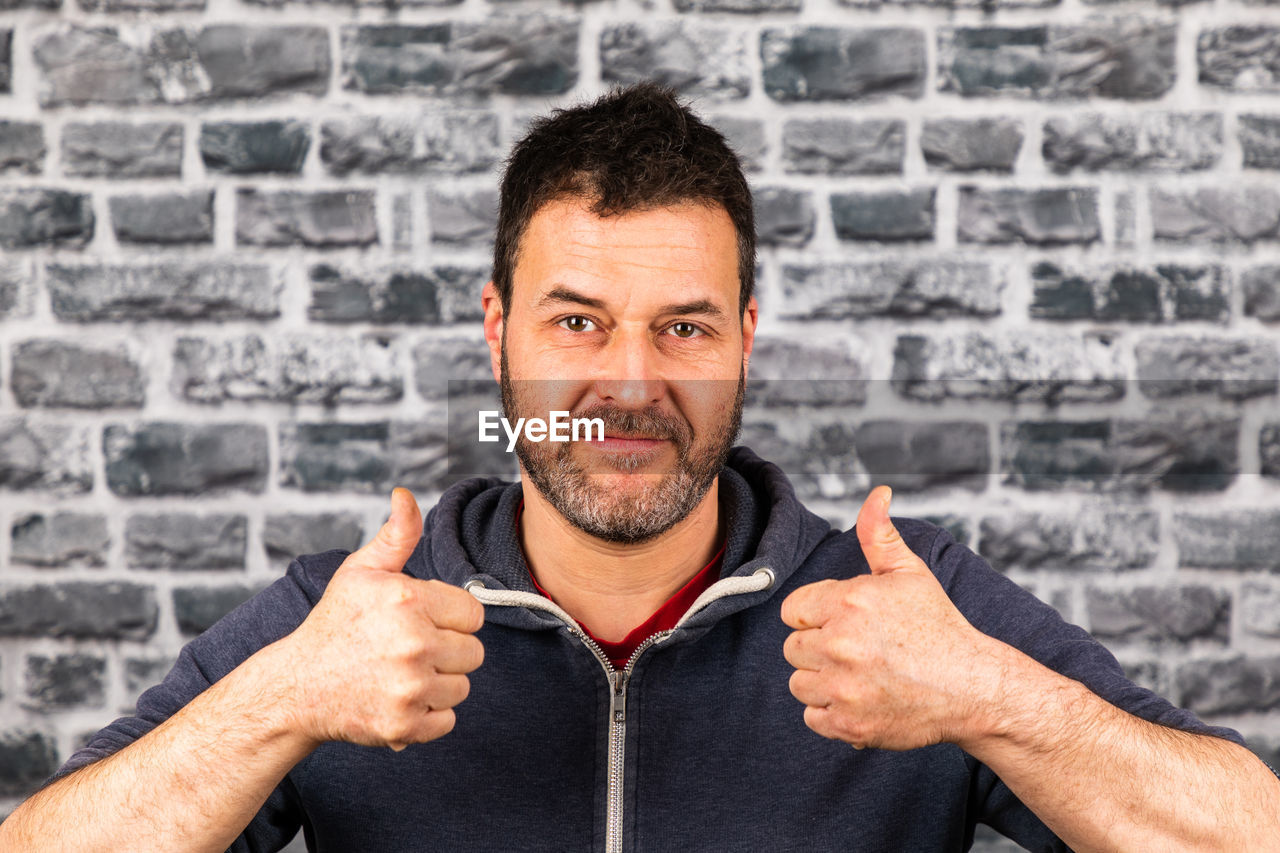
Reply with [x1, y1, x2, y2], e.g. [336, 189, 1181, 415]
[782, 485, 998, 749]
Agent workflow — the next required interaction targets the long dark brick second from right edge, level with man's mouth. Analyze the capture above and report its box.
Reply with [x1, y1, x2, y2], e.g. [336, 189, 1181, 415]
[1000, 411, 1240, 493]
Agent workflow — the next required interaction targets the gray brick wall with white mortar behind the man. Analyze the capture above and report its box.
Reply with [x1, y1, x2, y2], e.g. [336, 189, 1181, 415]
[0, 0, 1280, 840]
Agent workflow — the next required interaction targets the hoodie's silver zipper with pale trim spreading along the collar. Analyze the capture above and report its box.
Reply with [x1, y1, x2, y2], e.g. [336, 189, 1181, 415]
[462, 567, 774, 853]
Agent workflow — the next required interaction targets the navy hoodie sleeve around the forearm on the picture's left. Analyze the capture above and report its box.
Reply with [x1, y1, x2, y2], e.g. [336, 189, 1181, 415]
[44, 551, 347, 853]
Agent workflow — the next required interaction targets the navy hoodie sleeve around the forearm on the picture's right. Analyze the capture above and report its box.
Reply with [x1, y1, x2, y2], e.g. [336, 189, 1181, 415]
[928, 530, 1245, 850]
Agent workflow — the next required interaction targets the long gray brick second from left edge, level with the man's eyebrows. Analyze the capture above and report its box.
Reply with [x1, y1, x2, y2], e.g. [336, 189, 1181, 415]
[46, 261, 282, 321]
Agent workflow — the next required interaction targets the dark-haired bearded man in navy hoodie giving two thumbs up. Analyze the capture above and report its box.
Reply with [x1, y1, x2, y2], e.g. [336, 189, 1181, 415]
[0, 86, 1280, 853]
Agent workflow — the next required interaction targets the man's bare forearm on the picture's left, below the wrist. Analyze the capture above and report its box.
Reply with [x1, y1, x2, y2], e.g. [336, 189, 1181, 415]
[0, 643, 315, 853]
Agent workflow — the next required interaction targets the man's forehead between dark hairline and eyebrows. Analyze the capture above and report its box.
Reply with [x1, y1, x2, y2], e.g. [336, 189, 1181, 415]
[512, 199, 739, 304]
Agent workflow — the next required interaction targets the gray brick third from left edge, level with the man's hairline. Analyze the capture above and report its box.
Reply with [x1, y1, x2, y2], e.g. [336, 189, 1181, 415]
[236, 188, 378, 248]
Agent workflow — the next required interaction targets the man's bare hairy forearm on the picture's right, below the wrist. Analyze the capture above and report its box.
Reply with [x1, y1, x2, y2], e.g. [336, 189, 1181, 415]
[961, 640, 1280, 852]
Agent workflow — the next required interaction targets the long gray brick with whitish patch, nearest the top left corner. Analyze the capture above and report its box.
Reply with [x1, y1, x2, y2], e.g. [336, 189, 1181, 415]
[32, 24, 330, 106]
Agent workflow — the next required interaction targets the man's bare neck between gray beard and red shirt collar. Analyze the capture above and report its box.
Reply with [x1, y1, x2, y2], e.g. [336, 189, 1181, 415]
[520, 478, 722, 643]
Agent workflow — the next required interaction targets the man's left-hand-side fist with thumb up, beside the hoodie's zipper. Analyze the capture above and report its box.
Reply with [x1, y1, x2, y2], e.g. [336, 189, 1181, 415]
[282, 488, 484, 751]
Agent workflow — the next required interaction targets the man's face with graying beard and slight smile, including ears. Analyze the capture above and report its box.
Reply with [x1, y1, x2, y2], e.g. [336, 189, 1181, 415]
[485, 200, 756, 543]
